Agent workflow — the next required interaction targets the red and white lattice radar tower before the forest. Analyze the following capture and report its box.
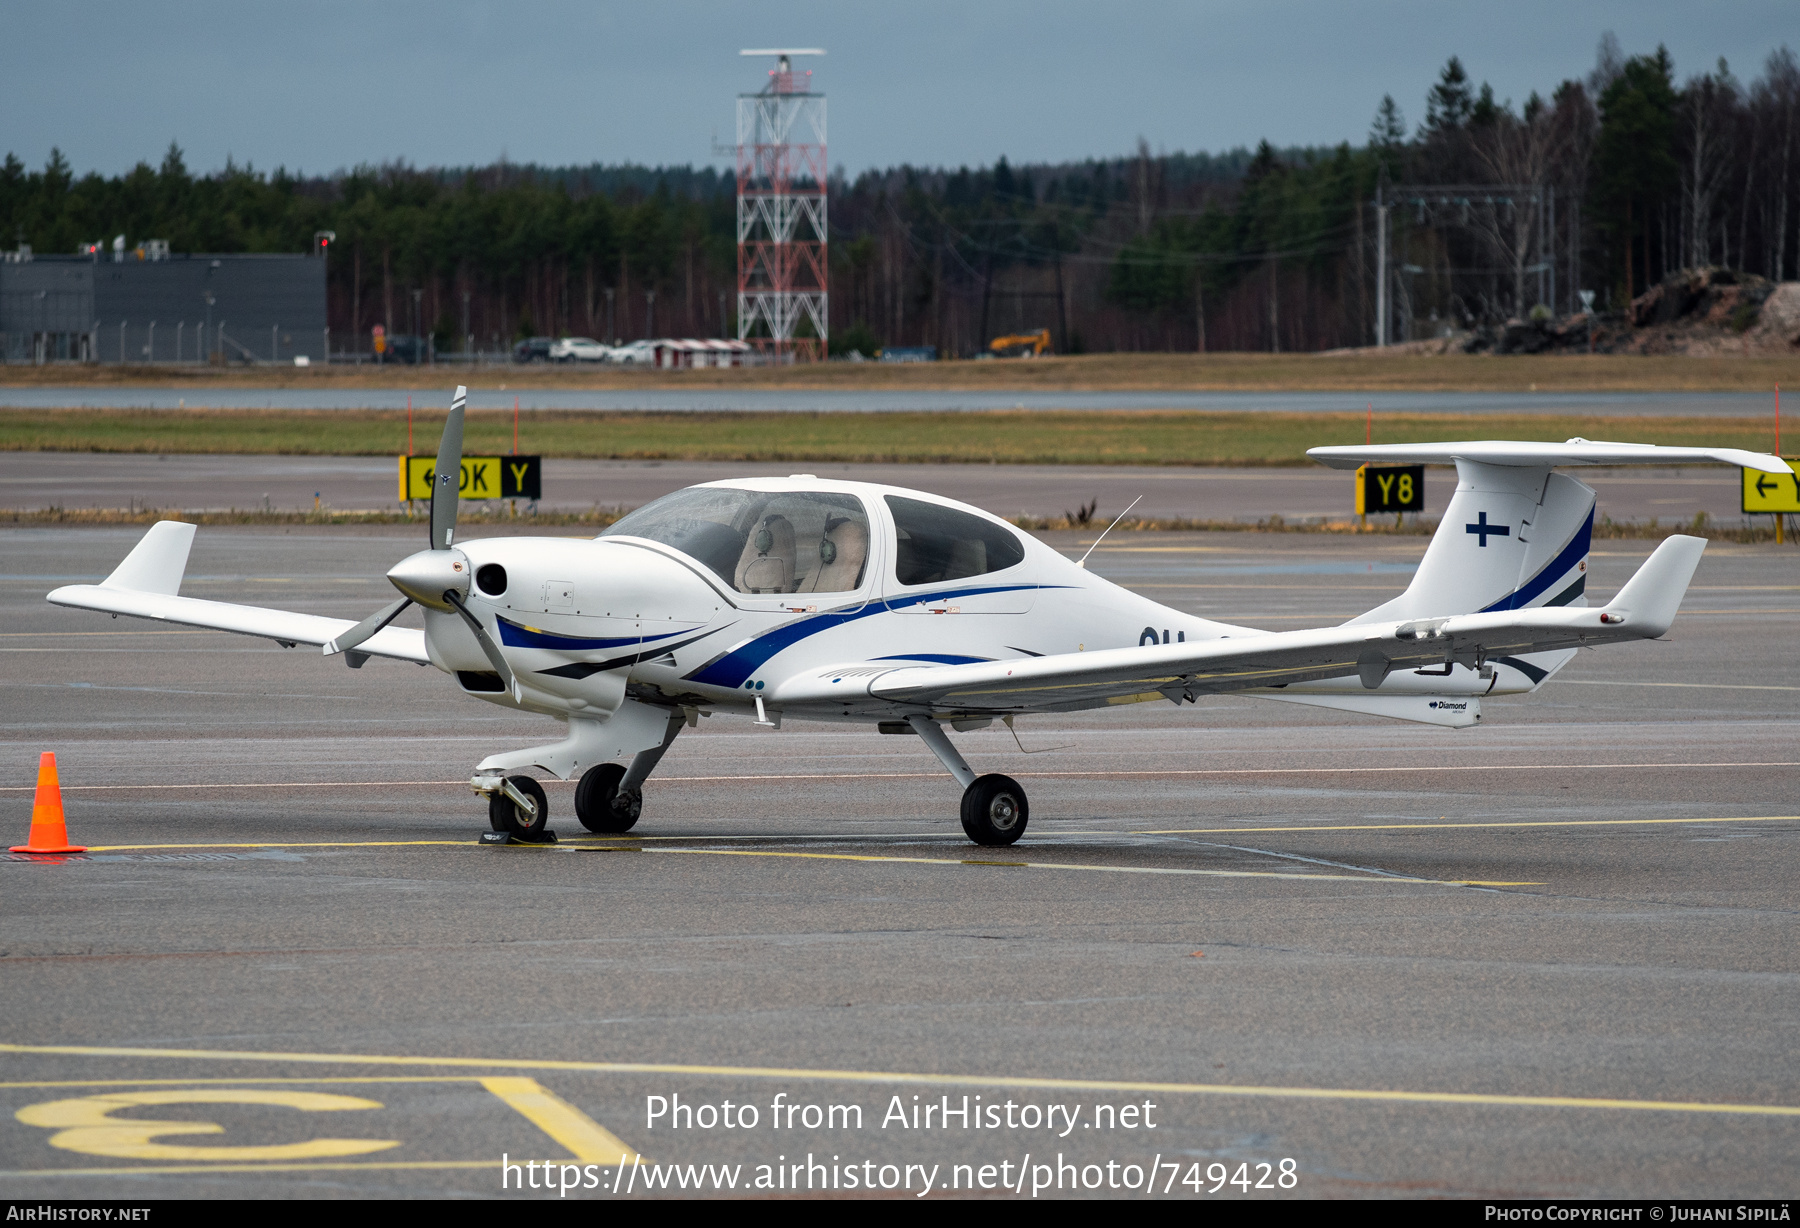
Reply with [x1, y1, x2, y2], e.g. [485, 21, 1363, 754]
[738, 47, 832, 362]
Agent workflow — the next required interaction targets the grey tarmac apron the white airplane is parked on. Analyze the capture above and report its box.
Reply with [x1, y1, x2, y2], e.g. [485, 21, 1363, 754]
[0, 522, 1800, 1199]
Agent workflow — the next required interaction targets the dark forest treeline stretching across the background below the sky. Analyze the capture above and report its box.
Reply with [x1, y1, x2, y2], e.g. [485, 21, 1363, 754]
[0, 36, 1800, 355]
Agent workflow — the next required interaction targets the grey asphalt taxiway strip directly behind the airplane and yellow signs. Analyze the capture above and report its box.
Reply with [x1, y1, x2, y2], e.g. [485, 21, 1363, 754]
[0, 452, 1768, 524]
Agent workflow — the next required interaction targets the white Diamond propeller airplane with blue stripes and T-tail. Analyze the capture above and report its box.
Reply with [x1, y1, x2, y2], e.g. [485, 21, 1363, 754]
[49, 387, 1787, 844]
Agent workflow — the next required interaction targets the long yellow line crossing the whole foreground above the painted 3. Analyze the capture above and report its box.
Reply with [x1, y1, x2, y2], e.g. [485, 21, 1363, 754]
[0, 1043, 1800, 1116]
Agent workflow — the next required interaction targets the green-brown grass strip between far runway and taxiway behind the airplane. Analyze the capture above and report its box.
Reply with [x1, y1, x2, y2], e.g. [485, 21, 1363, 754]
[0, 409, 1773, 466]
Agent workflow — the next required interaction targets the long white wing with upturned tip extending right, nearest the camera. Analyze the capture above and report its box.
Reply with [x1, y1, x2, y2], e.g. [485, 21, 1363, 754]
[772, 537, 1706, 713]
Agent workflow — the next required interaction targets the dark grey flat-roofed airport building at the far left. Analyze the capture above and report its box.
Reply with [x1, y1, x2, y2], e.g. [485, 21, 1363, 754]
[0, 245, 329, 362]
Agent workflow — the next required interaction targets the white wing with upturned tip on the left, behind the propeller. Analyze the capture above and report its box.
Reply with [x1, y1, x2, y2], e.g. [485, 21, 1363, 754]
[47, 520, 430, 664]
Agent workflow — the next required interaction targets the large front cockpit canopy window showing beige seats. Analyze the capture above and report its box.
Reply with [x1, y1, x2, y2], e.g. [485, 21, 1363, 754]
[599, 486, 869, 592]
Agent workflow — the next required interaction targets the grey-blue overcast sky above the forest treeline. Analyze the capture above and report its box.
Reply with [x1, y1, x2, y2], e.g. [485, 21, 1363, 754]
[0, 0, 1800, 175]
